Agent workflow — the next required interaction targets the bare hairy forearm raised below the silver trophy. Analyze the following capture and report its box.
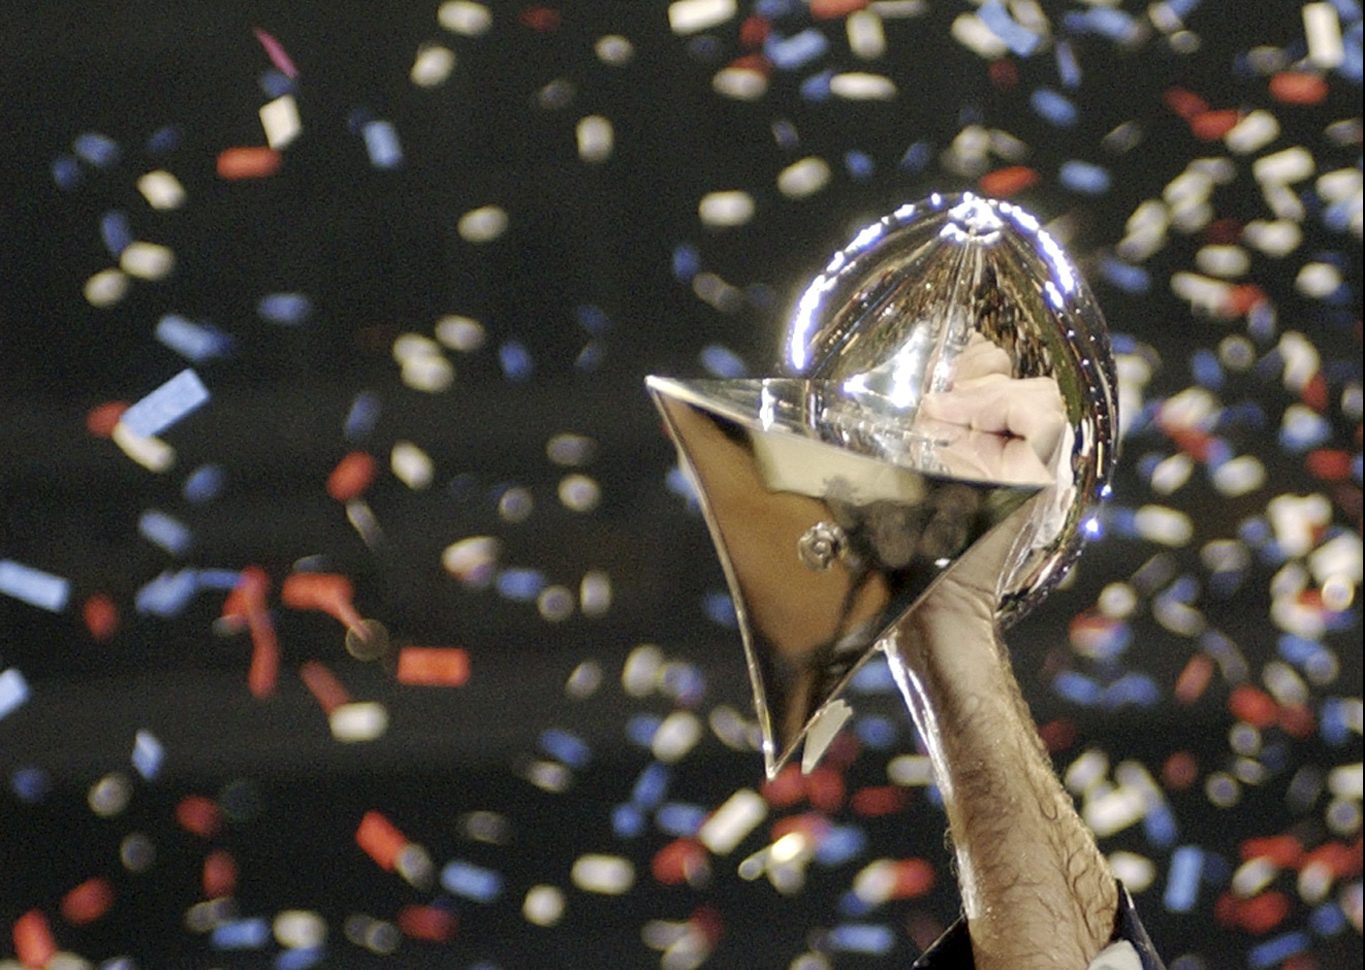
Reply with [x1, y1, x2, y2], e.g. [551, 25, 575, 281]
[891, 610, 1117, 970]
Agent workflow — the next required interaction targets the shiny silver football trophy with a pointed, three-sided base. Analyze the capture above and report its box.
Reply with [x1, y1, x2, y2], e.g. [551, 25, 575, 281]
[648, 195, 1117, 775]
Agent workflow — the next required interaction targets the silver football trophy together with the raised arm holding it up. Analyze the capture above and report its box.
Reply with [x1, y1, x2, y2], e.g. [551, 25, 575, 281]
[647, 195, 1160, 970]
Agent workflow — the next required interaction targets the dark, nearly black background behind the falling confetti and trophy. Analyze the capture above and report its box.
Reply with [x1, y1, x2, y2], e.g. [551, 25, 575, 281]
[0, 0, 1361, 970]
